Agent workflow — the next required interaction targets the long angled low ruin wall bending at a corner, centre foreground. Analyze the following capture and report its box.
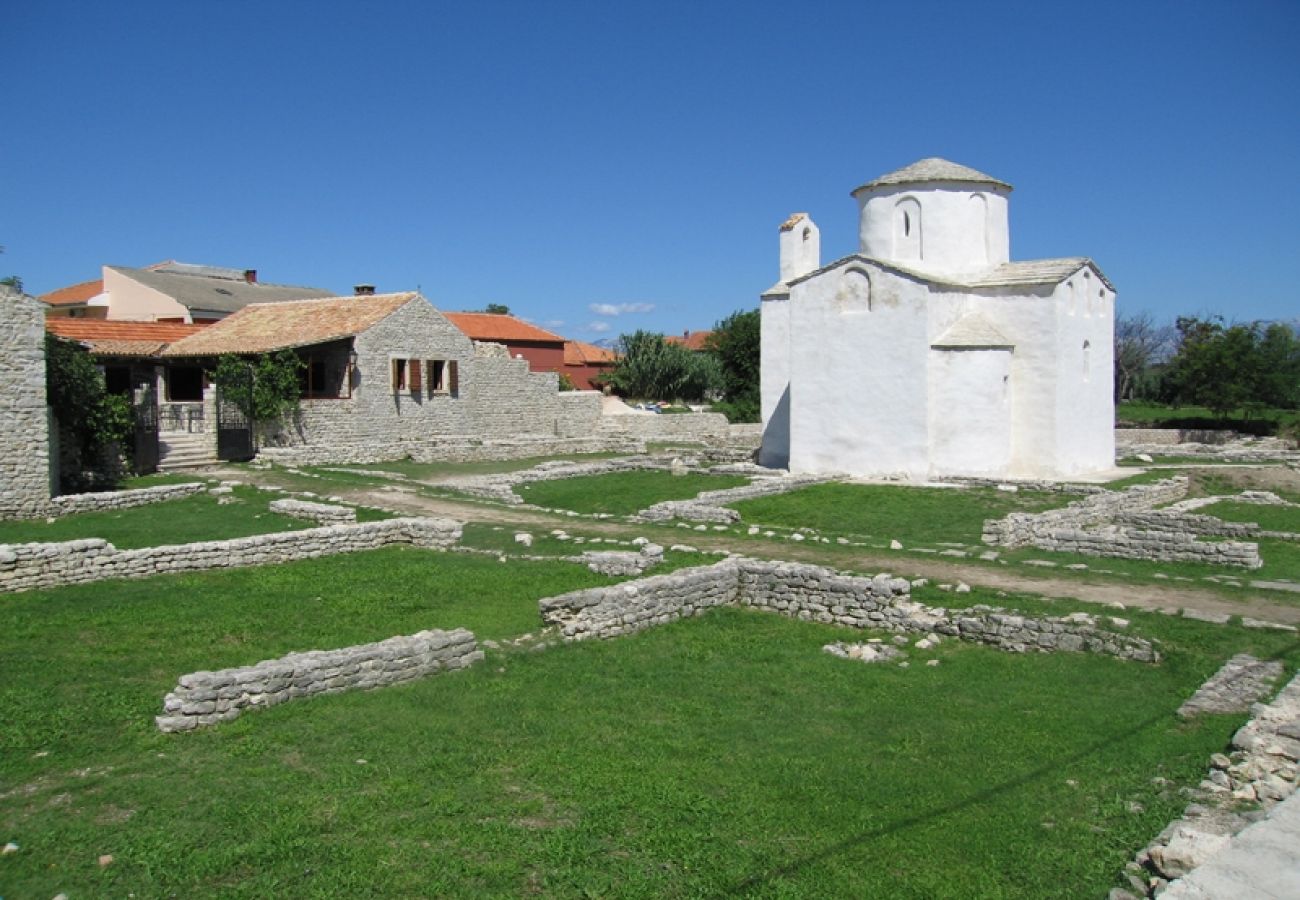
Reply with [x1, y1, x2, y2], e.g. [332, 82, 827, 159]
[540, 558, 1160, 662]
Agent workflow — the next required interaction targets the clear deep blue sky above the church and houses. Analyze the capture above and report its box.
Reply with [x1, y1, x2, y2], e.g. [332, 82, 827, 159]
[0, 0, 1300, 339]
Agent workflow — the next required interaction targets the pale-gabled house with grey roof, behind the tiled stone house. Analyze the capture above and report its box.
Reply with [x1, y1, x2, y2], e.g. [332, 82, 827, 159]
[39, 260, 332, 325]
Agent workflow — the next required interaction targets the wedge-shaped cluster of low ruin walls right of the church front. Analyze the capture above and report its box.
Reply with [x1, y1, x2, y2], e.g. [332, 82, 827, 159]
[983, 477, 1264, 568]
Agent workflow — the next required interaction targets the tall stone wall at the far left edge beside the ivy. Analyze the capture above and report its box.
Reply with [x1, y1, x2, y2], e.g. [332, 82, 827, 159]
[0, 286, 51, 519]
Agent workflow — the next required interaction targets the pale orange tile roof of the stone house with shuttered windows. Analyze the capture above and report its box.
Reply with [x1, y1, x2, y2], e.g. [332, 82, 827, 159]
[163, 291, 416, 356]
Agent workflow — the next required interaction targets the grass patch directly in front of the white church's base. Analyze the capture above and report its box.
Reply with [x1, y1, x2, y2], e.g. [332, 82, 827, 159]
[731, 484, 1078, 546]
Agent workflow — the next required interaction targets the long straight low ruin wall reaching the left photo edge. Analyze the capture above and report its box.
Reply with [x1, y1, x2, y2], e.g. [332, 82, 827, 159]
[0, 519, 460, 593]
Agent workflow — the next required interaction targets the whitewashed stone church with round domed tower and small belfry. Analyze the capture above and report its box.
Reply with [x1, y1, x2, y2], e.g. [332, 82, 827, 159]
[759, 159, 1115, 480]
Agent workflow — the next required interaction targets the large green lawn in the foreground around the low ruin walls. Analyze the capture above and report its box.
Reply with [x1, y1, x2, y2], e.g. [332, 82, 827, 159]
[0, 549, 1295, 897]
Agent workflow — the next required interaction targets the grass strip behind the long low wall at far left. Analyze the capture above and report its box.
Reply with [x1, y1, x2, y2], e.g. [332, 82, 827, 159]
[0, 486, 387, 550]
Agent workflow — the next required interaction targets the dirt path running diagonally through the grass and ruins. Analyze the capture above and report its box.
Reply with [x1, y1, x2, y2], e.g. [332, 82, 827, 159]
[218, 470, 1300, 626]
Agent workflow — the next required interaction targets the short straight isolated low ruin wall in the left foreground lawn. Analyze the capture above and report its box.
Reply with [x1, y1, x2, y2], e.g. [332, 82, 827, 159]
[153, 628, 484, 732]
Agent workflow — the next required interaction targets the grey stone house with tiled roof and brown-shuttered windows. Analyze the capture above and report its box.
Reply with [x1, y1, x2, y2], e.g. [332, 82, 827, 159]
[161, 291, 601, 460]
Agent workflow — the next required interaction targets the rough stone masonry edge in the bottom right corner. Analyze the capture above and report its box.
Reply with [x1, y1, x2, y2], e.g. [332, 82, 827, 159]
[1132, 655, 1300, 897]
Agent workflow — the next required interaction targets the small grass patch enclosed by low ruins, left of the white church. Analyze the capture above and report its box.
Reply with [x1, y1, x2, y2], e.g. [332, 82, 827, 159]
[515, 471, 749, 515]
